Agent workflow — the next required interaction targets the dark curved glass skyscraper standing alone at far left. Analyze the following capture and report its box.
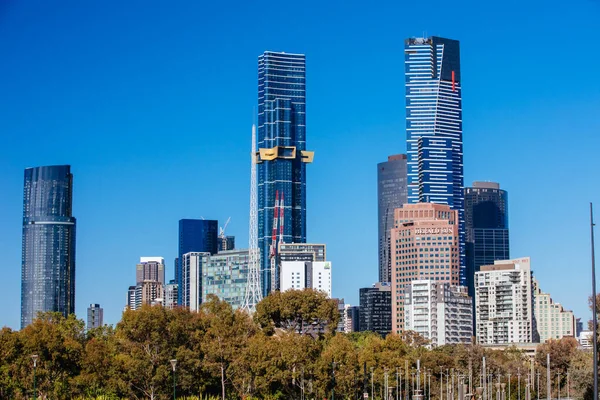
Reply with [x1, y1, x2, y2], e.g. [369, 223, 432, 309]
[21, 165, 76, 328]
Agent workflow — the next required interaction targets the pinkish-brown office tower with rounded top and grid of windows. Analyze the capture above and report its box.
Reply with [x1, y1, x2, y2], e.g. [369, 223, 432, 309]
[391, 203, 460, 334]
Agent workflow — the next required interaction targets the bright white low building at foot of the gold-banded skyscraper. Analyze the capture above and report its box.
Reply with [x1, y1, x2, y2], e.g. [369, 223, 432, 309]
[280, 261, 331, 298]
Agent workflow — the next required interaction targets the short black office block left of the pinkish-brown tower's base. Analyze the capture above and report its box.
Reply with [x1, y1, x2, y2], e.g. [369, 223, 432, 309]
[359, 282, 392, 337]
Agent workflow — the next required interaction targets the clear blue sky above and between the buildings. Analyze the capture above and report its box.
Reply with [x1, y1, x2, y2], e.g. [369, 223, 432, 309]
[0, 0, 600, 328]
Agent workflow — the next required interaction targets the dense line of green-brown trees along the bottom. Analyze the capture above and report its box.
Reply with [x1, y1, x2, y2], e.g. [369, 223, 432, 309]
[0, 290, 592, 399]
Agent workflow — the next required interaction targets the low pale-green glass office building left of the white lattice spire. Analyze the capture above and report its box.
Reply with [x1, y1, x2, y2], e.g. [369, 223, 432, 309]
[202, 249, 250, 309]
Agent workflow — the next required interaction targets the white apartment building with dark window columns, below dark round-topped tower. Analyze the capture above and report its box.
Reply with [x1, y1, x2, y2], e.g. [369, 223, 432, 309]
[475, 257, 539, 344]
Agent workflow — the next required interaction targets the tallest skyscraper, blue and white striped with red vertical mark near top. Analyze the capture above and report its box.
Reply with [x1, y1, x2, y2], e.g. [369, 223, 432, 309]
[404, 36, 466, 285]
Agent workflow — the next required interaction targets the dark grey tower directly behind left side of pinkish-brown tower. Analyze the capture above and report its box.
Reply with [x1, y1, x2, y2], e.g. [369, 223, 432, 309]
[377, 154, 408, 282]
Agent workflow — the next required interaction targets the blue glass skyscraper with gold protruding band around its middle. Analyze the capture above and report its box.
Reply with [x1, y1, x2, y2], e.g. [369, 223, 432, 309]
[256, 51, 314, 296]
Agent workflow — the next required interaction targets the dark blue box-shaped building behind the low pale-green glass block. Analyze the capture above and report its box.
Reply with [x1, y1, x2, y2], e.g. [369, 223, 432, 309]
[175, 219, 219, 305]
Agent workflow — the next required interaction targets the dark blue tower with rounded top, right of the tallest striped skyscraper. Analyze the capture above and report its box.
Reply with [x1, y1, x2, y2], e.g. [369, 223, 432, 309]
[465, 182, 510, 296]
